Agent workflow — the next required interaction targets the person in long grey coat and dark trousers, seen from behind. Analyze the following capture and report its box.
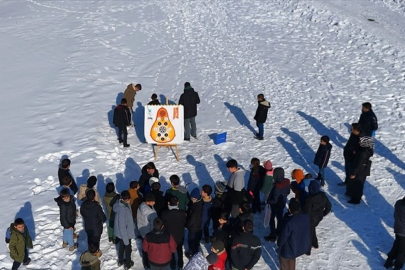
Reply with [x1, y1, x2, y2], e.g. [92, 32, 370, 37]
[113, 190, 135, 269]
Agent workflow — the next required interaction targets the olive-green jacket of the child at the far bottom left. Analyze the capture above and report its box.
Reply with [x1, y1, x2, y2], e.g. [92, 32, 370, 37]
[8, 223, 33, 263]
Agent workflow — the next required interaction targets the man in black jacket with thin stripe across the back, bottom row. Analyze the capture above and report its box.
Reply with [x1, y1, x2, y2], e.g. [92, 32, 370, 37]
[231, 219, 262, 270]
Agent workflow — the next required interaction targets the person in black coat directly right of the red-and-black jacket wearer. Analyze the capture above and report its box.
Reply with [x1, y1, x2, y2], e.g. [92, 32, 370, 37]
[162, 196, 187, 269]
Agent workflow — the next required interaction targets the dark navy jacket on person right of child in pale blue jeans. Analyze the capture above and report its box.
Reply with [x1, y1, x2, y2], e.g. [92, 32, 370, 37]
[80, 200, 107, 236]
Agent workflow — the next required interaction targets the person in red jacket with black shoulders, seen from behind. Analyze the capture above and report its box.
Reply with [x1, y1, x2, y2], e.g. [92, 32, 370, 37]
[142, 218, 177, 270]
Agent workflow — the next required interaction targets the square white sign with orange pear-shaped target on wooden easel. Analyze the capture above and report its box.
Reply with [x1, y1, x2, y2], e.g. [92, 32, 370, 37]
[144, 105, 184, 144]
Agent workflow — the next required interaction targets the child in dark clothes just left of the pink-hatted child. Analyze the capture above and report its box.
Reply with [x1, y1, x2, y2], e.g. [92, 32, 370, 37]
[248, 158, 265, 213]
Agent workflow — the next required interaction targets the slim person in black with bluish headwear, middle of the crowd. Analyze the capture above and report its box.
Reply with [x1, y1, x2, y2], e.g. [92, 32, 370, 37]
[186, 188, 203, 258]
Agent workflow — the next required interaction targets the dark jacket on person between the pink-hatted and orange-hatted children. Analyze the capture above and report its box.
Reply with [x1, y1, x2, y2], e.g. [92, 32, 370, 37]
[267, 167, 290, 211]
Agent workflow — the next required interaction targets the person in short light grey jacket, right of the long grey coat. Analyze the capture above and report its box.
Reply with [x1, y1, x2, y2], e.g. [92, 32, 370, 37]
[136, 192, 157, 268]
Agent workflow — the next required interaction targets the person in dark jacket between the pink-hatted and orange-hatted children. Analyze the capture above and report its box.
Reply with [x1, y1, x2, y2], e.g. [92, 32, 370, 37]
[264, 167, 290, 242]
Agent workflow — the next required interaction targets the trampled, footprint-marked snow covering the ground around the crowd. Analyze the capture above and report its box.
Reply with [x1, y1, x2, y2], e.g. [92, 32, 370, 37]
[0, 0, 405, 270]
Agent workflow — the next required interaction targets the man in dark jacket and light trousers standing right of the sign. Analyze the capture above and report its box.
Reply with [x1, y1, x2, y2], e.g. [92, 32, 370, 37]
[179, 82, 200, 141]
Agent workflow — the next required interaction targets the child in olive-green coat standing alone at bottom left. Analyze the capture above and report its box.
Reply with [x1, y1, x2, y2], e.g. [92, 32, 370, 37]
[9, 218, 33, 270]
